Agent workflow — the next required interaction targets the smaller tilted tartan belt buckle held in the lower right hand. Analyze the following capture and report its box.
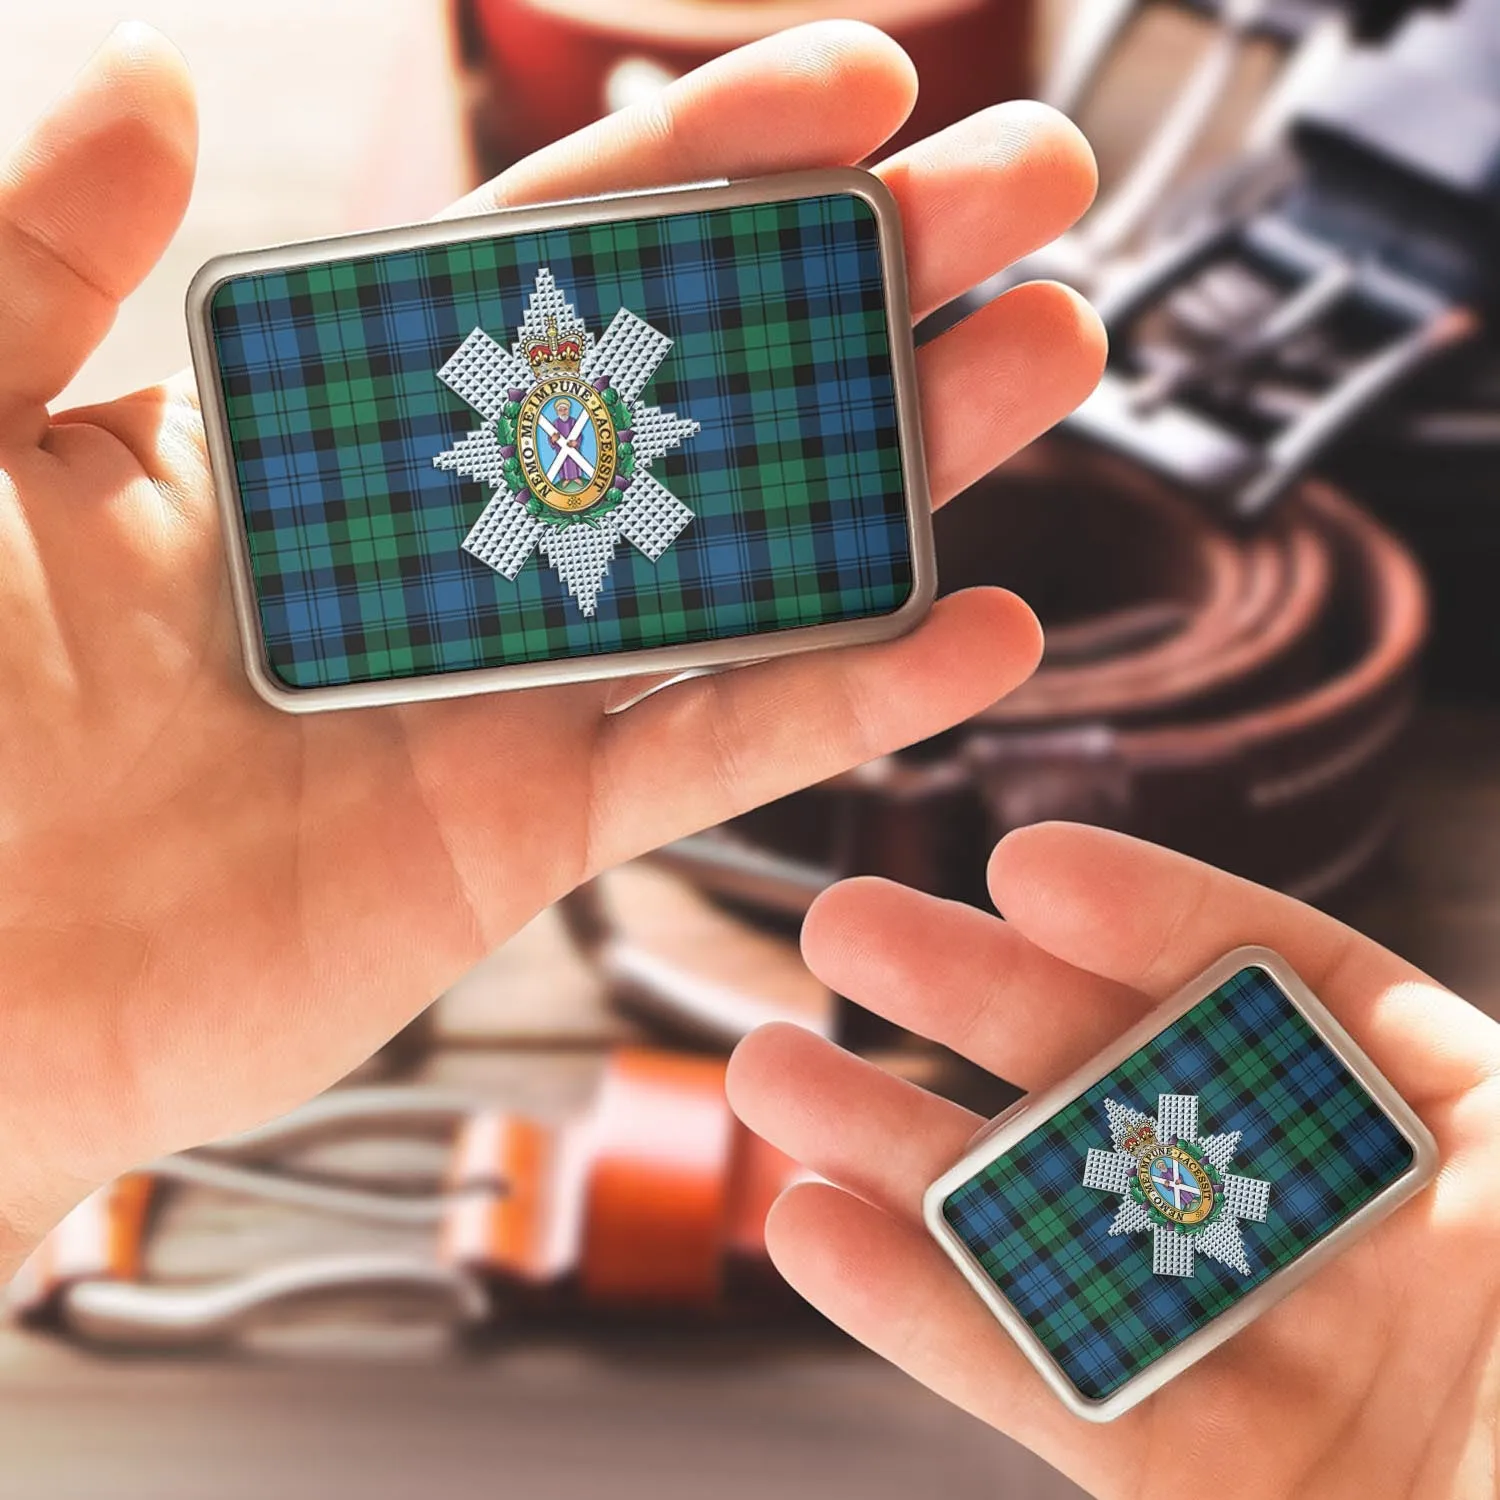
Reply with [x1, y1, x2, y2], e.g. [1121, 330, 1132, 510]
[924, 948, 1437, 1422]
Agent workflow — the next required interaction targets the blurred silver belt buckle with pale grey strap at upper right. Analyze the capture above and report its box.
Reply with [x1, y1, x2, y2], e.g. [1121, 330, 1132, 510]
[1070, 0, 1500, 521]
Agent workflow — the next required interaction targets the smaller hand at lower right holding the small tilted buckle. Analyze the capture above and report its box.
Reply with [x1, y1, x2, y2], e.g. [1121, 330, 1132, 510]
[729, 824, 1500, 1500]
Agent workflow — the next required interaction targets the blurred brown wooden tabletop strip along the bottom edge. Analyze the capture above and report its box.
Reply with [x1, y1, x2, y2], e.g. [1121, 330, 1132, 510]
[0, 1341, 1077, 1500]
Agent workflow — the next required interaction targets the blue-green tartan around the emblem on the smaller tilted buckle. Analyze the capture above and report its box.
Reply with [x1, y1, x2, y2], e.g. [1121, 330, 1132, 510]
[944, 968, 1413, 1400]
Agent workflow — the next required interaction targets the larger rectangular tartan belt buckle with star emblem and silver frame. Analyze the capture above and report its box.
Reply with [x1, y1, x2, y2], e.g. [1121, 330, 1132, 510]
[189, 170, 933, 710]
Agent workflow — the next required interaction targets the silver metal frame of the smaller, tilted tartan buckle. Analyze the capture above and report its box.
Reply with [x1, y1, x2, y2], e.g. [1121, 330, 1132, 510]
[923, 948, 1437, 1422]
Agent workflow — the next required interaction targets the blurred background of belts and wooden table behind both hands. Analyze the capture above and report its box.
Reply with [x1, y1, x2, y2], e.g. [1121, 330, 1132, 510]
[0, 0, 1500, 1500]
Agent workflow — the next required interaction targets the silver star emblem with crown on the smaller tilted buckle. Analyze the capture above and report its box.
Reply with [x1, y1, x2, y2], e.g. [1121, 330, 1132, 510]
[1083, 1094, 1271, 1277]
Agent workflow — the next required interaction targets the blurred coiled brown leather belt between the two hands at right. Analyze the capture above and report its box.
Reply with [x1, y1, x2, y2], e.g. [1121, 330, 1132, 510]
[734, 440, 1427, 903]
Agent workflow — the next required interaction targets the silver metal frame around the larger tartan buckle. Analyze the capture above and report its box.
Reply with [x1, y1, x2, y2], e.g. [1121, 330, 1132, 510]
[188, 167, 938, 713]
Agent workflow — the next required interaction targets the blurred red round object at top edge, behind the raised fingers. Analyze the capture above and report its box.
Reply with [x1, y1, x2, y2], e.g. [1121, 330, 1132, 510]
[458, 0, 1032, 167]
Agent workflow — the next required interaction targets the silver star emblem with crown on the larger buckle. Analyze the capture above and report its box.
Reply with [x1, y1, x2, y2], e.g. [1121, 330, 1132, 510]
[432, 269, 699, 615]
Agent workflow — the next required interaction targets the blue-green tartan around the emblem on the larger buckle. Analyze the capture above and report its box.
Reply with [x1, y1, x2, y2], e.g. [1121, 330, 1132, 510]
[212, 194, 912, 687]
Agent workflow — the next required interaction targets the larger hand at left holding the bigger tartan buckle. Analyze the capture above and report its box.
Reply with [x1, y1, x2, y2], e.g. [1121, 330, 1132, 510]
[0, 24, 1103, 1271]
